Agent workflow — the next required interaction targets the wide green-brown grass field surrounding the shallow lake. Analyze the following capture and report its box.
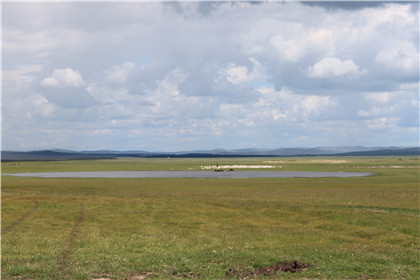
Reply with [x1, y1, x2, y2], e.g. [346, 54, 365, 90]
[1, 157, 420, 280]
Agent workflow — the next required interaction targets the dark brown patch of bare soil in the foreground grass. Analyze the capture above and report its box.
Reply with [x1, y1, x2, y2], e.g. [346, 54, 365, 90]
[226, 261, 312, 279]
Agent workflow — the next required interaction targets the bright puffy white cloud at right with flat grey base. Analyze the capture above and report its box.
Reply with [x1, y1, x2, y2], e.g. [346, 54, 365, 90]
[306, 57, 368, 78]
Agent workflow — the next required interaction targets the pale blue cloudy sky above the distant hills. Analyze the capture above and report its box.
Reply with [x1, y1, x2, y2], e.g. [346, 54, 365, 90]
[1, 1, 419, 152]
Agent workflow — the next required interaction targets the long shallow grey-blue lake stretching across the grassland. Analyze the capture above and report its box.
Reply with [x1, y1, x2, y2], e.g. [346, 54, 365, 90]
[5, 171, 372, 178]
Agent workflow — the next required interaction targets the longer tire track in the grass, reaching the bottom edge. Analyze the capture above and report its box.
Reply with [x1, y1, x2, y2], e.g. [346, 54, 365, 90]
[58, 203, 85, 279]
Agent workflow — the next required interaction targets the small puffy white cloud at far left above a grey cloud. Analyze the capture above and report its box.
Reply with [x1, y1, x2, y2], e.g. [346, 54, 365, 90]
[41, 68, 86, 88]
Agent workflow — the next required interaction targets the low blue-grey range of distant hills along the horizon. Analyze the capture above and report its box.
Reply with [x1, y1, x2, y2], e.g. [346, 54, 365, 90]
[1, 146, 420, 161]
